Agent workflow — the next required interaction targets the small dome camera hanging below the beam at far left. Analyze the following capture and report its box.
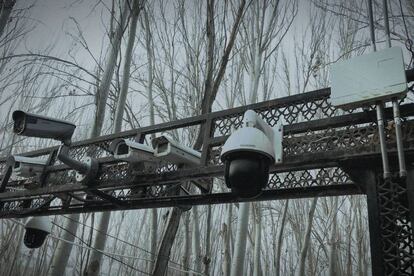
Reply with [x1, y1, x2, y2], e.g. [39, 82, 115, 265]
[24, 217, 52, 248]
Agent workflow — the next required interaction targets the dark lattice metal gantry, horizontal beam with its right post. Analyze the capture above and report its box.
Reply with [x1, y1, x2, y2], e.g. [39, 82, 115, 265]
[0, 89, 414, 275]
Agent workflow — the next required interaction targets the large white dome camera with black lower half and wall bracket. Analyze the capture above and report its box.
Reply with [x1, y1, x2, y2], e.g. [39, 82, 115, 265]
[220, 110, 283, 198]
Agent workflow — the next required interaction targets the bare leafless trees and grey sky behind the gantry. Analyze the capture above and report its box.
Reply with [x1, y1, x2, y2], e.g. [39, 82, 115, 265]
[0, 0, 414, 276]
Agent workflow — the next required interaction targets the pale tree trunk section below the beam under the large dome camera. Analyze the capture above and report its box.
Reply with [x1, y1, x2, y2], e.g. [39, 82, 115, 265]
[230, 202, 250, 276]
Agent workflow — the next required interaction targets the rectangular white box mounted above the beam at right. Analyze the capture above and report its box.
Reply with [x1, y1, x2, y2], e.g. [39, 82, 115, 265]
[331, 47, 407, 109]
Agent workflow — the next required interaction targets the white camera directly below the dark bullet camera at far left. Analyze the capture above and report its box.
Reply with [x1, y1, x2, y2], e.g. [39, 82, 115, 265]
[13, 156, 47, 177]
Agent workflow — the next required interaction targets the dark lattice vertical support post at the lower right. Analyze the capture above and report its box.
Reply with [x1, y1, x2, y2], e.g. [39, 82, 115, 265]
[344, 164, 414, 276]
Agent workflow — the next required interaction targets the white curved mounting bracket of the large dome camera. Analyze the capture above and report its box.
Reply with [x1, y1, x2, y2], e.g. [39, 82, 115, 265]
[243, 110, 283, 164]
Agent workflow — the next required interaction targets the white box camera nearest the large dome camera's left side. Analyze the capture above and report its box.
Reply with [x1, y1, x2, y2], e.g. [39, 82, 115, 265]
[152, 134, 201, 166]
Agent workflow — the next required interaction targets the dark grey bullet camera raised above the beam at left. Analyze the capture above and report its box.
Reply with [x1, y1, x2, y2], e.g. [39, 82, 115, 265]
[12, 110, 76, 143]
